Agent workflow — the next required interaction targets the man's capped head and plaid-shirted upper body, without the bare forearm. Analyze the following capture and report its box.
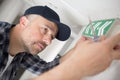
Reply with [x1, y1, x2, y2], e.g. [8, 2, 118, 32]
[0, 6, 70, 80]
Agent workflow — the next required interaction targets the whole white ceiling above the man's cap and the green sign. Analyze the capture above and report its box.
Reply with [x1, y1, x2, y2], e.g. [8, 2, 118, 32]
[24, 0, 120, 30]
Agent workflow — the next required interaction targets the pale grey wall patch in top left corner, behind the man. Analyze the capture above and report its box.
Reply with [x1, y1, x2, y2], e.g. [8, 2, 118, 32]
[0, 0, 23, 23]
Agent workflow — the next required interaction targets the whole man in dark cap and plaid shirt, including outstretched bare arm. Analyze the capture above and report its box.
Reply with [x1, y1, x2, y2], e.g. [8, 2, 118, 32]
[0, 6, 120, 80]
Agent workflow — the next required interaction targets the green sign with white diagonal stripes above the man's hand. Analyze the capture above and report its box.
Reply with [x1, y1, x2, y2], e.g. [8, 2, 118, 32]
[82, 19, 115, 37]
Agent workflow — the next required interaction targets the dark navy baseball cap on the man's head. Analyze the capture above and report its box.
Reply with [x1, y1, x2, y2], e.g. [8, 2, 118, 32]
[24, 6, 71, 41]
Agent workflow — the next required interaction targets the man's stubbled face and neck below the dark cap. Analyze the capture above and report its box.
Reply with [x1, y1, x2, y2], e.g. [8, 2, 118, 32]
[10, 15, 58, 56]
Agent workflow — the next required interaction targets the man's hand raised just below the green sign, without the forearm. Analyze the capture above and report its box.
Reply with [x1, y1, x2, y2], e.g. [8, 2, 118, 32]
[72, 34, 120, 76]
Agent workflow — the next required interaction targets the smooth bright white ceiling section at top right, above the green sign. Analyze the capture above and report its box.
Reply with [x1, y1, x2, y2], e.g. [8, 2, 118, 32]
[64, 0, 120, 20]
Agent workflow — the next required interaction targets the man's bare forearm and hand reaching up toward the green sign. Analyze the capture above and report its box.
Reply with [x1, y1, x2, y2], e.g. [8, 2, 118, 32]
[33, 34, 120, 80]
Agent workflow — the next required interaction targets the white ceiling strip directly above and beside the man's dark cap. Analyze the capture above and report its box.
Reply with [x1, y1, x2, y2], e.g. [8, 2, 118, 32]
[24, 0, 88, 26]
